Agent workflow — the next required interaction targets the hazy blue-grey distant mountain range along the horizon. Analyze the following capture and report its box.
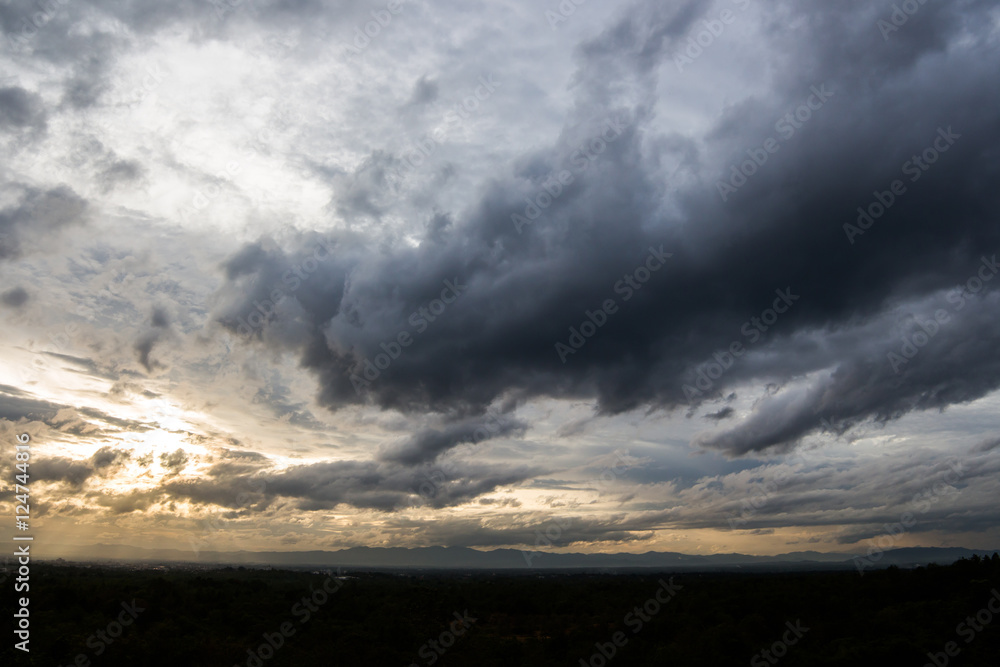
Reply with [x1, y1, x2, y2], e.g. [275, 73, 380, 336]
[48, 544, 993, 571]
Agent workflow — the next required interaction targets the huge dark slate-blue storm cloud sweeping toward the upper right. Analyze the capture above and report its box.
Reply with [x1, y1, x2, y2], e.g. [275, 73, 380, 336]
[207, 2, 1000, 455]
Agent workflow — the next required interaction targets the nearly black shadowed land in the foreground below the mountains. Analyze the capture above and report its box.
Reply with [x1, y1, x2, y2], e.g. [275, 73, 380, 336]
[0, 557, 1000, 667]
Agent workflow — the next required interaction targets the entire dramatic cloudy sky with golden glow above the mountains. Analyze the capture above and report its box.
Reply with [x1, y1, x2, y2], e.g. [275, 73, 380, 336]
[0, 0, 1000, 556]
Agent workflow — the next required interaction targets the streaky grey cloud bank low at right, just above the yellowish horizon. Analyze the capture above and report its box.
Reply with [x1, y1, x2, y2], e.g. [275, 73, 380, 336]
[656, 453, 1000, 544]
